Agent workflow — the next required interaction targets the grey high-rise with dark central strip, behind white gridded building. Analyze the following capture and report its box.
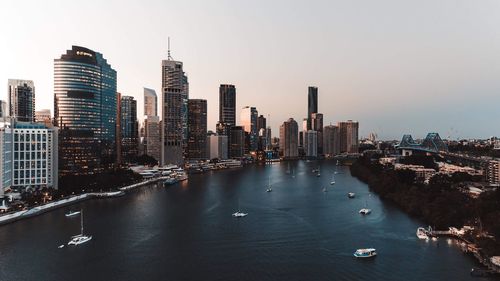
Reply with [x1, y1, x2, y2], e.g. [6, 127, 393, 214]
[9, 79, 35, 122]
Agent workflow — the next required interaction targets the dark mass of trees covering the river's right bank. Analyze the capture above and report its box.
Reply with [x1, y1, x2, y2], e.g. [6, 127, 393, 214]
[351, 154, 500, 255]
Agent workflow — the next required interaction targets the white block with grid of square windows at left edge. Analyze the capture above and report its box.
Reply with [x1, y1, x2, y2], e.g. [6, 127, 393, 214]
[0, 119, 58, 195]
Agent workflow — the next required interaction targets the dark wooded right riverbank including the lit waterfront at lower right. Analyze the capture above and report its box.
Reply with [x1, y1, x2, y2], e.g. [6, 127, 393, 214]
[350, 159, 500, 273]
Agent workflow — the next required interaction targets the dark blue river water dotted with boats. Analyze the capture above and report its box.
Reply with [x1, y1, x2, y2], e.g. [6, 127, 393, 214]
[0, 161, 494, 281]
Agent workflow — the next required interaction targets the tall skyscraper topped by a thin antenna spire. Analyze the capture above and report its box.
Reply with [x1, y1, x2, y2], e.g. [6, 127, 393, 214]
[161, 50, 189, 165]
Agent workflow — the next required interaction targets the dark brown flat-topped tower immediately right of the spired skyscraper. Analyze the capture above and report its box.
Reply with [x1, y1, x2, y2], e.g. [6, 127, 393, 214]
[187, 99, 208, 160]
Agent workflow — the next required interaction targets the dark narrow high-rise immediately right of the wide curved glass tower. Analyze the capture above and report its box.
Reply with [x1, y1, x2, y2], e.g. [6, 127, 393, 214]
[120, 96, 139, 163]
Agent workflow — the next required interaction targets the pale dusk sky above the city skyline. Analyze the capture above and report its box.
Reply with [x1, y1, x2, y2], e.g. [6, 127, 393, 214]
[0, 0, 500, 139]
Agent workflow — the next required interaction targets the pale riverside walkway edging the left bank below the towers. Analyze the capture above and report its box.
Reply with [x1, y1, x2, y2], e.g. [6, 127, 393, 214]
[0, 177, 166, 226]
